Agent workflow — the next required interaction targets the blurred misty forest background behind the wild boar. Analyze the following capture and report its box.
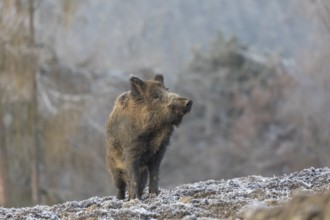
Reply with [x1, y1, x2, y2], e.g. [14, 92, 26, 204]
[0, 0, 330, 207]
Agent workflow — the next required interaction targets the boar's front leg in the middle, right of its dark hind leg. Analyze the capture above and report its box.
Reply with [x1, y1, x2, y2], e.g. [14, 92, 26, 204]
[125, 152, 142, 200]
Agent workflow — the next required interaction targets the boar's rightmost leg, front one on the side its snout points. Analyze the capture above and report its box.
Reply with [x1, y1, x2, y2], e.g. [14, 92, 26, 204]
[148, 147, 165, 195]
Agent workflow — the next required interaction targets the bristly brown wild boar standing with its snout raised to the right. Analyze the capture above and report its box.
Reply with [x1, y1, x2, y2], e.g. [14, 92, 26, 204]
[106, 74, 192, 199]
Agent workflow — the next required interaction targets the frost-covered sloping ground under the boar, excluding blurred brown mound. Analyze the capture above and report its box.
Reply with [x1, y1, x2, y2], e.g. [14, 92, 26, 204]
[0, 168, 330, 220]
